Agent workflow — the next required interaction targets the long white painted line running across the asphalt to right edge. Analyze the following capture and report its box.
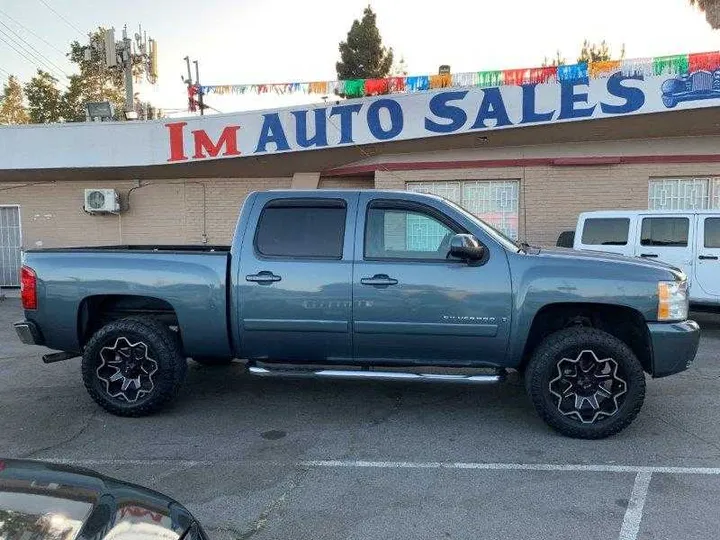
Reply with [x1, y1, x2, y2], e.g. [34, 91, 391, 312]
[300, 460, 720, 475]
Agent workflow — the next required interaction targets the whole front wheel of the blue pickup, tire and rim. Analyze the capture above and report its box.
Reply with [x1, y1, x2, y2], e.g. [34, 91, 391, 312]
[525, 327, 645, 439]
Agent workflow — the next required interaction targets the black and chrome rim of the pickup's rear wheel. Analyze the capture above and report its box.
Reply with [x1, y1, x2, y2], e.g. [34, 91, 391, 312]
[95, 336, 158, 403]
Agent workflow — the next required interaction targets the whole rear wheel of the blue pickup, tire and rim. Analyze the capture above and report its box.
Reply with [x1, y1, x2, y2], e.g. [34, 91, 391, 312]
[82, 317, 187, 416]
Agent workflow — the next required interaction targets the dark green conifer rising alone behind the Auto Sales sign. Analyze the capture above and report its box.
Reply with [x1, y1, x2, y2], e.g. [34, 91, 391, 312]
[335, 6, 393, 80]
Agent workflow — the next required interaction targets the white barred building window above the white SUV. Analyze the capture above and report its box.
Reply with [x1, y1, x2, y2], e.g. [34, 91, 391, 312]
[648, 178, 720, 210]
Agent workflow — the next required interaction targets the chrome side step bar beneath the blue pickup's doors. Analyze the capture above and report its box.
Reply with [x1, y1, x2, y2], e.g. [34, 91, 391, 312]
[248, 366, 505, 384]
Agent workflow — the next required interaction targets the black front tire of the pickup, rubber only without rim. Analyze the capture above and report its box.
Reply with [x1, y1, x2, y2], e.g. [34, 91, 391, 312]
[525, 327, 645, 439]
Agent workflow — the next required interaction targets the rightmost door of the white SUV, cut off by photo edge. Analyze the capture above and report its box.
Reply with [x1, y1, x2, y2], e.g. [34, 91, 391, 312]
[690, 214, 720, 301]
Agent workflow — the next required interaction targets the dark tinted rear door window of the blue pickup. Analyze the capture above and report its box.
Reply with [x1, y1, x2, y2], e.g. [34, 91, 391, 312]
[255, 199, 347, 259]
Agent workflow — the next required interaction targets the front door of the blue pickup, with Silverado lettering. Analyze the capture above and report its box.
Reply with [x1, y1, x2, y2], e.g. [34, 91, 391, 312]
[353, 193, 512, 365]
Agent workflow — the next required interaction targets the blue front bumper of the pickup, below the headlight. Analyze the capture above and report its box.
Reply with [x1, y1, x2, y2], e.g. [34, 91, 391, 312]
[647, 321, 700, 378]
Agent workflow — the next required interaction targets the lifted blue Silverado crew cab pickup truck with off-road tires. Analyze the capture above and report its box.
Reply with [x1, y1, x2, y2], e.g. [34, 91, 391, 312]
[15, 190, 699, 439]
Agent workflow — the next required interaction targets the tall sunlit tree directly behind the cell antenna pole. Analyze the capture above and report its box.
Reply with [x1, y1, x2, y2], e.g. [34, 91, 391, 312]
[60, 28, 125, 122]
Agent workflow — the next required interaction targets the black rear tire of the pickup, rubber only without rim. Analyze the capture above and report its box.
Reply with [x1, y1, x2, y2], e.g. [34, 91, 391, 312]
[82, 316, 187, 417]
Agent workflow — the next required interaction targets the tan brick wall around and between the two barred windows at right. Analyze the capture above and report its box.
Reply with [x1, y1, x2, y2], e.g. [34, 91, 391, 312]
[375, 163, 720, 246]
